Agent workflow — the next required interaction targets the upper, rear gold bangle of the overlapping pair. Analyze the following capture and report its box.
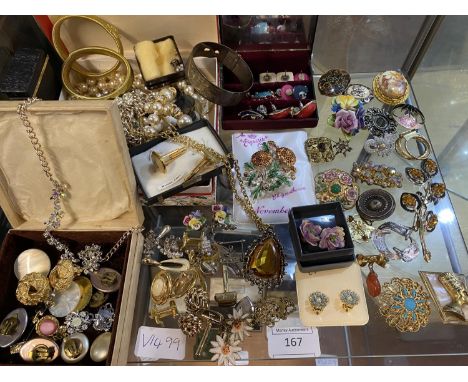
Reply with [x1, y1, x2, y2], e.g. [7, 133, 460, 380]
[52, 15, 123, 77]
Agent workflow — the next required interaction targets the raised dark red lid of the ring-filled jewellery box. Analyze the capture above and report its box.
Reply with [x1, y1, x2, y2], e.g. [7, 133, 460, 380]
[218, 15, 318, 52]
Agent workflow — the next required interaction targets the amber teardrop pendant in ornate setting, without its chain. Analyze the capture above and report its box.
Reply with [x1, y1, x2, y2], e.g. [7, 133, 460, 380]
[244, 234, 285, 287]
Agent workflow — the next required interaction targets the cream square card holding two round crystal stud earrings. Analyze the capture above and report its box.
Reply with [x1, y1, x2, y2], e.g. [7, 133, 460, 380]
[296, 262, 369, 327]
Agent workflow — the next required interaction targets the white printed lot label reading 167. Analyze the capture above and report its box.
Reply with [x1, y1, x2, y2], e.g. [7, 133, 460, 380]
[267, 327, 321, 358]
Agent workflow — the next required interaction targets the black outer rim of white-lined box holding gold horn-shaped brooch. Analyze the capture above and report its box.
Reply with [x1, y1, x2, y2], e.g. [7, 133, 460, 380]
[130, 119, 228, 204]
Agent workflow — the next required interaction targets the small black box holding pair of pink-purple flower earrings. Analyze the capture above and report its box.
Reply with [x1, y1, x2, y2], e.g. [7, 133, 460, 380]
[289, 202, 355, 272]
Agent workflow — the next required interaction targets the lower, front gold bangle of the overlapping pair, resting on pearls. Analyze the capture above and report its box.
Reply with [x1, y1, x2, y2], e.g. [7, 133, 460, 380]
[62, 46, 133, 100]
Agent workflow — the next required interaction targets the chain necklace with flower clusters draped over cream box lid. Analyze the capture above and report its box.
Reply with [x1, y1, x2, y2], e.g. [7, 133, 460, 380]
[17, 97, 143, 280]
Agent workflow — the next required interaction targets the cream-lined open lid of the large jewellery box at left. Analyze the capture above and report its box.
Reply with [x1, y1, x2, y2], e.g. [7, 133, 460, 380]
[0, 101, 143, 230]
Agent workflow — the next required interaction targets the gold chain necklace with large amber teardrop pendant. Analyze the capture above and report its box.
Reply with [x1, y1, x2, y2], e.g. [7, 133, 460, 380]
[159, 126, 286, 288]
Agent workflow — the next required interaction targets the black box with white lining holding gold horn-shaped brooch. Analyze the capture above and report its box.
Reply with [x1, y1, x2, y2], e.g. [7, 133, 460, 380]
[130, 119, 229, 205]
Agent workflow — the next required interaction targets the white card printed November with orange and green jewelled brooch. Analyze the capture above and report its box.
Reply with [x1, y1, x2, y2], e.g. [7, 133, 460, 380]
[232, 130, 316, 224]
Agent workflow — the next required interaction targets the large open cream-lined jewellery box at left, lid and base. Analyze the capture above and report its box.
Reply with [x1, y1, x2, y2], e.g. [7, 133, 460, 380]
[0, 101, 143, 365]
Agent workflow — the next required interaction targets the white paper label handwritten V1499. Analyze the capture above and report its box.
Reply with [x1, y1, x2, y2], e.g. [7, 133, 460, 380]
[134, 326, 186, 361]
